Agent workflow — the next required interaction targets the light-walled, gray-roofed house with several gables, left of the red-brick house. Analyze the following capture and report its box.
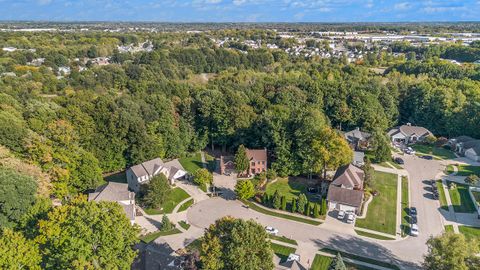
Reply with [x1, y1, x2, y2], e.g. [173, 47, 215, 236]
[127, 158, 187, 192]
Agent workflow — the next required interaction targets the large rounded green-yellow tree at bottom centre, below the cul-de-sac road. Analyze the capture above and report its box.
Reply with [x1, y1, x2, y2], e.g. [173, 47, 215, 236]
[200, 217, 274, 270]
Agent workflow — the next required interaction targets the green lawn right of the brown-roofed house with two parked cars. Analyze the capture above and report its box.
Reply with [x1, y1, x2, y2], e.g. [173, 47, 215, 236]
[356, 171, 398, 235]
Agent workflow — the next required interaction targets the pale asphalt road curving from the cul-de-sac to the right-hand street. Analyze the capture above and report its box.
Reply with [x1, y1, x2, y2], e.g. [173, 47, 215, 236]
[187, 153, 443, 269]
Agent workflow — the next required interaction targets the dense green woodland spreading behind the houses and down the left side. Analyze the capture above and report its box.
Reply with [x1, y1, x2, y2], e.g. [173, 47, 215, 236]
[0, 27, 480, 269]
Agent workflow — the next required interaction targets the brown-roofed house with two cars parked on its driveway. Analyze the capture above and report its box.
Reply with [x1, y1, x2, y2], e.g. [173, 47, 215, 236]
[327, 164, 365, 214]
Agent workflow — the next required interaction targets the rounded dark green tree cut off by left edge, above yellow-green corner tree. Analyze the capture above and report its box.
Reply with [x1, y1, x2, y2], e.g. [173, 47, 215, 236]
[0, 167, 37, 229]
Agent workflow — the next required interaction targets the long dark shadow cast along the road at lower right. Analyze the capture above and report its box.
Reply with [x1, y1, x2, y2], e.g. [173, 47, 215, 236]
[314, 235, 419, 269]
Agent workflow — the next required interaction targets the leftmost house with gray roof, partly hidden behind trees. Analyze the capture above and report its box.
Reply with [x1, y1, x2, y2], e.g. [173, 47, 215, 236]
[88, 182, 135, 225]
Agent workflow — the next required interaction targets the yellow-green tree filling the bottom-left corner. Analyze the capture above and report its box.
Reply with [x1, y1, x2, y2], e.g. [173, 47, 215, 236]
[0, 229, 42, 270]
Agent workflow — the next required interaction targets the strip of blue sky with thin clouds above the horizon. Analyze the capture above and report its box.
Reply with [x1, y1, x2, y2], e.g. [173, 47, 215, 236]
[0, 0, 480, 22]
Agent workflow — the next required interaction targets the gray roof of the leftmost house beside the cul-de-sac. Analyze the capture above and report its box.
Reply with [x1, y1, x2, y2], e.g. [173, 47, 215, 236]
[88, 182, 135, 202]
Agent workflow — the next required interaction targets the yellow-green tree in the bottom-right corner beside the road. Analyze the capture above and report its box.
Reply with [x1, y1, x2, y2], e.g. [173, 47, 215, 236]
[423, 233, 480, 270]
